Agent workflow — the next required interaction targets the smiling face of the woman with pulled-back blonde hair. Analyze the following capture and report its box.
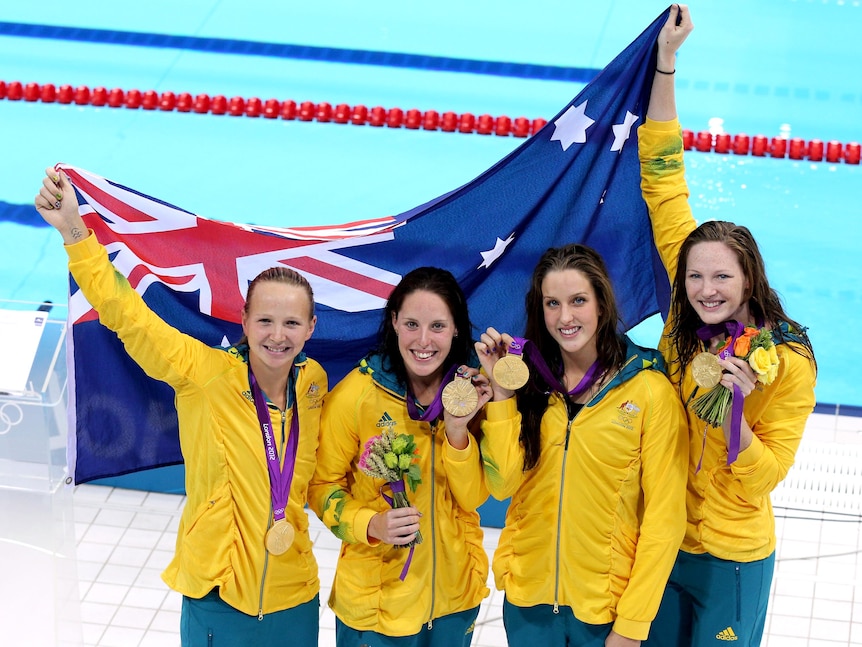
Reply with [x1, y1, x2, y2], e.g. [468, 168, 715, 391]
[242, 281, 317, 378]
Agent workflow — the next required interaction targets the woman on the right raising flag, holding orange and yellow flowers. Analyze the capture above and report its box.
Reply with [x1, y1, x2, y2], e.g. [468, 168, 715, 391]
[638, 5, 816, 647]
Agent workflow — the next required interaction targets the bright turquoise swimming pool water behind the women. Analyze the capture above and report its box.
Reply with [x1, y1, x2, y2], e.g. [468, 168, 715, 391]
[0, 0, 862, 406]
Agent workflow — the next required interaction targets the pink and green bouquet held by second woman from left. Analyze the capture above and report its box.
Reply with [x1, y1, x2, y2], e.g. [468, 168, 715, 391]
[359, 429, 422, 548]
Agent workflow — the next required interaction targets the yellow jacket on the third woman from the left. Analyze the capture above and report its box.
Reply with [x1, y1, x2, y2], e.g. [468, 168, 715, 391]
[481, 342, 688, 640]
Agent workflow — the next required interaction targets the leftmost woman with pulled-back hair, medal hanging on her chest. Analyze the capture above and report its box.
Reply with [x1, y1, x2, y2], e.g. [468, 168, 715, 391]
[35, 169, 327, 647]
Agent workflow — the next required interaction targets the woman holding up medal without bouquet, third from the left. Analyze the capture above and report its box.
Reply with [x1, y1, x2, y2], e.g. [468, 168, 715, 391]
[476, 244, 687, 647]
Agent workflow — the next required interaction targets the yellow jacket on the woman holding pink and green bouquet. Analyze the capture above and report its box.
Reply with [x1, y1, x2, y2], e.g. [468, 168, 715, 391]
[309, 354, 488, 636]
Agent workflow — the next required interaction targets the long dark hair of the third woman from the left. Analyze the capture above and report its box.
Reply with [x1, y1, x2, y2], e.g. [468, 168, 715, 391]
[518, 243, 626, 471]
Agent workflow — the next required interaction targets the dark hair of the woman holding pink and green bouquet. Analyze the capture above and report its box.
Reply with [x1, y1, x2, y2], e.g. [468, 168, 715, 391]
[377, 267, 473, 388]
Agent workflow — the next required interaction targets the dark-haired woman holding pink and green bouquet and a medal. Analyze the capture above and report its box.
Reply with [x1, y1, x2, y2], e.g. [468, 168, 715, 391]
[309, 267, 491, 647]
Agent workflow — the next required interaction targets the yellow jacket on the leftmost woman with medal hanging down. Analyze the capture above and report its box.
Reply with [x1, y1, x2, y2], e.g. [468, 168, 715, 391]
[66, 233, 327, 615]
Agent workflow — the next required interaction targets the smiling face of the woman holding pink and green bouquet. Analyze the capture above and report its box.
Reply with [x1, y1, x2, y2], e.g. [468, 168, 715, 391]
[392, 290, 458, 390]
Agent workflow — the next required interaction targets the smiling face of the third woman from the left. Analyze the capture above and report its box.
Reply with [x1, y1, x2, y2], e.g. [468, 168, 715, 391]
[542, 270, 600, 358]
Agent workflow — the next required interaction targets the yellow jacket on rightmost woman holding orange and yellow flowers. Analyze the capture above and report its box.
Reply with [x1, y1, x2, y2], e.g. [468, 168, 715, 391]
[638, 119, 815, 562]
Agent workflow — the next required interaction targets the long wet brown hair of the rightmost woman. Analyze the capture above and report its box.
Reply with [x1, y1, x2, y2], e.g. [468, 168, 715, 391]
[669, 220, 814, 388]
